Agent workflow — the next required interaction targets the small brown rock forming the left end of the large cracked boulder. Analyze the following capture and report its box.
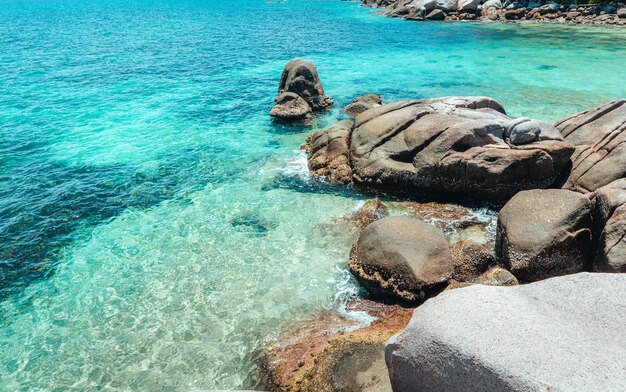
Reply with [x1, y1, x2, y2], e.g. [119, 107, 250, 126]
[304, 120, 352, 184]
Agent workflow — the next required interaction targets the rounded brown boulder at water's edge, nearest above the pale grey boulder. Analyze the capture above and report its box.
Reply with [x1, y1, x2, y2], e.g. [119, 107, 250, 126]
[349, 216, 453, 302]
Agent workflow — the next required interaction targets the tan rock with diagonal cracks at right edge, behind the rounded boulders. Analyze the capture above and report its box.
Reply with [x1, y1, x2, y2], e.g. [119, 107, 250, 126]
[555, 99, 626, 193]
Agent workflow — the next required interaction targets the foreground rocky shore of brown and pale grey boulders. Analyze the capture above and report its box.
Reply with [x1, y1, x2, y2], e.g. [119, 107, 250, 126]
[264, 61, 626, 392]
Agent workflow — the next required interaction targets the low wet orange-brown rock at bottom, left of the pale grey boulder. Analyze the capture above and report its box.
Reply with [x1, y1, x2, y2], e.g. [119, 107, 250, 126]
[262, 299, 413, 392]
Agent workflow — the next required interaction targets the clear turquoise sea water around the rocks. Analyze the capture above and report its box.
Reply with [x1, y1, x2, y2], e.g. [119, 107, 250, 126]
[0, 0, 626, 390]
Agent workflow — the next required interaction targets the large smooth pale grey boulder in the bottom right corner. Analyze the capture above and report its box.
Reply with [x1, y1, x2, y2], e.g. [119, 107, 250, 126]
[385, 273, 626, 392]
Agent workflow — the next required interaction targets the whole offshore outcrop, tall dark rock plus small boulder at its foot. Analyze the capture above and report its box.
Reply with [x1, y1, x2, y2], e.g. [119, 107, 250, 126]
[270, 59, 333, 120]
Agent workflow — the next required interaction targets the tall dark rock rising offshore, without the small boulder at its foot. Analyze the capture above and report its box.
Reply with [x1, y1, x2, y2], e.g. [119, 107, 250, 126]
[278, 59, 333, 111]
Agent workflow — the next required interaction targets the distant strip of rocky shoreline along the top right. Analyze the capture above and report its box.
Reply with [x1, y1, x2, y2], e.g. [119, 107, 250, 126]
[363, 0, 626, 26]
